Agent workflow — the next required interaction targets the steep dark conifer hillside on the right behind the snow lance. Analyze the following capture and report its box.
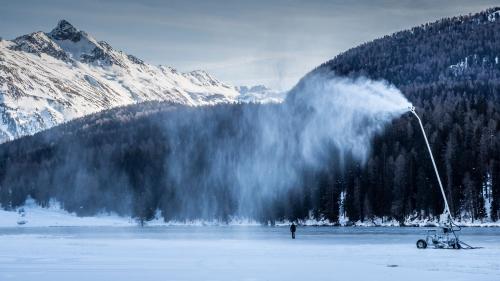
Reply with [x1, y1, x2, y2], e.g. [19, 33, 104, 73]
[304, 8, 500, 220]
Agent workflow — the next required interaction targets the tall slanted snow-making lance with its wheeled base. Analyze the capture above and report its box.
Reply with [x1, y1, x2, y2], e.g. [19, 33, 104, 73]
[408, 105, 477, 249]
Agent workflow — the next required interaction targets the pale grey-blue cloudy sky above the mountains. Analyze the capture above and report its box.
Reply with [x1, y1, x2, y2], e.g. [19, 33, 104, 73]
[0, 0, 500, 90]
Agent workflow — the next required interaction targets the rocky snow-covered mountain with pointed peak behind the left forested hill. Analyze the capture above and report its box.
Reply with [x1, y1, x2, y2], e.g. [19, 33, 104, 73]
[0, 20, 274, 142]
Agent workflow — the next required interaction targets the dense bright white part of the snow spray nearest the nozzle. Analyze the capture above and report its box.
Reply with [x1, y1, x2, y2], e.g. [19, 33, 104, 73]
[289, 71, 411, 164]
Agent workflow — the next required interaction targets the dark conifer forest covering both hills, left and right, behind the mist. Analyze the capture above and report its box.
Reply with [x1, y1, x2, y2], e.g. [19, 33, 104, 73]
[0, 7, 500, 222]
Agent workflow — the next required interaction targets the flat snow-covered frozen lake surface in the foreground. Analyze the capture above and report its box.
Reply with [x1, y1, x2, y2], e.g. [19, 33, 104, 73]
[0, 226, 500, 281]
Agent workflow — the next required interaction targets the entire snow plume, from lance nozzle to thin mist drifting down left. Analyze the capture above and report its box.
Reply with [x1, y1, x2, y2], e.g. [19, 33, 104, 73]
[156, 71, 410, 219]
